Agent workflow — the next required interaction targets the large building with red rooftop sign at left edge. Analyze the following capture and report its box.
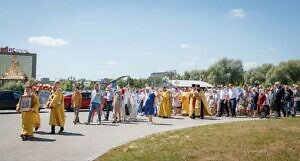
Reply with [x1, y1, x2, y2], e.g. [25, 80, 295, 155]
[0, 47, 36, 83]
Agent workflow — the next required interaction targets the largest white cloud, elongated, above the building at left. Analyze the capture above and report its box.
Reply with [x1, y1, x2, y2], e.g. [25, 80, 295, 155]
[27, 36, 69, 46]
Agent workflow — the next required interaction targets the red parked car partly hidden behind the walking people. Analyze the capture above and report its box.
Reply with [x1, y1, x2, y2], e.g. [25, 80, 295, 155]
[64, 91, 91, 111]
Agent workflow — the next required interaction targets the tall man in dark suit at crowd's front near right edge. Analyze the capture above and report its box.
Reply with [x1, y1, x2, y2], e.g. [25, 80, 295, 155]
[273, 82, 286, 117]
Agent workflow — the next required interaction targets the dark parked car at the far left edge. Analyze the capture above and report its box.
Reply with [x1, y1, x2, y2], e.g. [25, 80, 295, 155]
[0, 91, 23, 110]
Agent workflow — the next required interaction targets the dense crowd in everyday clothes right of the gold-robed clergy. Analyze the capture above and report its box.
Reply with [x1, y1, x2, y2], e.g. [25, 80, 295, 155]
[206, 82, 300, 118]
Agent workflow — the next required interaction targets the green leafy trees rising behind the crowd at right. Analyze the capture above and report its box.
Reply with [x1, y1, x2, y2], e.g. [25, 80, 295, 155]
[177, 58, 300, 86]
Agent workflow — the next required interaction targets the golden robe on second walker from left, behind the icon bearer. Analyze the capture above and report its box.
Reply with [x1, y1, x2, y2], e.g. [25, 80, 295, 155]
[48, 90, 65, 127]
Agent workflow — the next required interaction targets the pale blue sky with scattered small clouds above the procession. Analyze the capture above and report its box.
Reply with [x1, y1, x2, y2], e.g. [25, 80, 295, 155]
[0, 0, 300, 79]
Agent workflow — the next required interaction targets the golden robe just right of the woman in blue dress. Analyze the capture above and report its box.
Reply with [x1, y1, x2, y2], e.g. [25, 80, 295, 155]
[158, 91, 172, 117]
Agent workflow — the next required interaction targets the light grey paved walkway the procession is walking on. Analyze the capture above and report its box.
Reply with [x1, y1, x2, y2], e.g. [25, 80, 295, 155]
[0, 110, 255, 161]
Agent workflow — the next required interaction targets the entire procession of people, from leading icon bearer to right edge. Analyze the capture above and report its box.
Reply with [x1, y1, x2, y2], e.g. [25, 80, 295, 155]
[17, 81, 300, 140]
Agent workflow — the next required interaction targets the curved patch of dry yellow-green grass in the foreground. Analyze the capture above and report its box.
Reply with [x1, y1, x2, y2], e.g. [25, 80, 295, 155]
[97, 117, 300, 161]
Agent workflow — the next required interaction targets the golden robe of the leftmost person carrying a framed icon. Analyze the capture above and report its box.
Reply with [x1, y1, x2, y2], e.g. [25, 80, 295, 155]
[17, 94, 40, 136]
